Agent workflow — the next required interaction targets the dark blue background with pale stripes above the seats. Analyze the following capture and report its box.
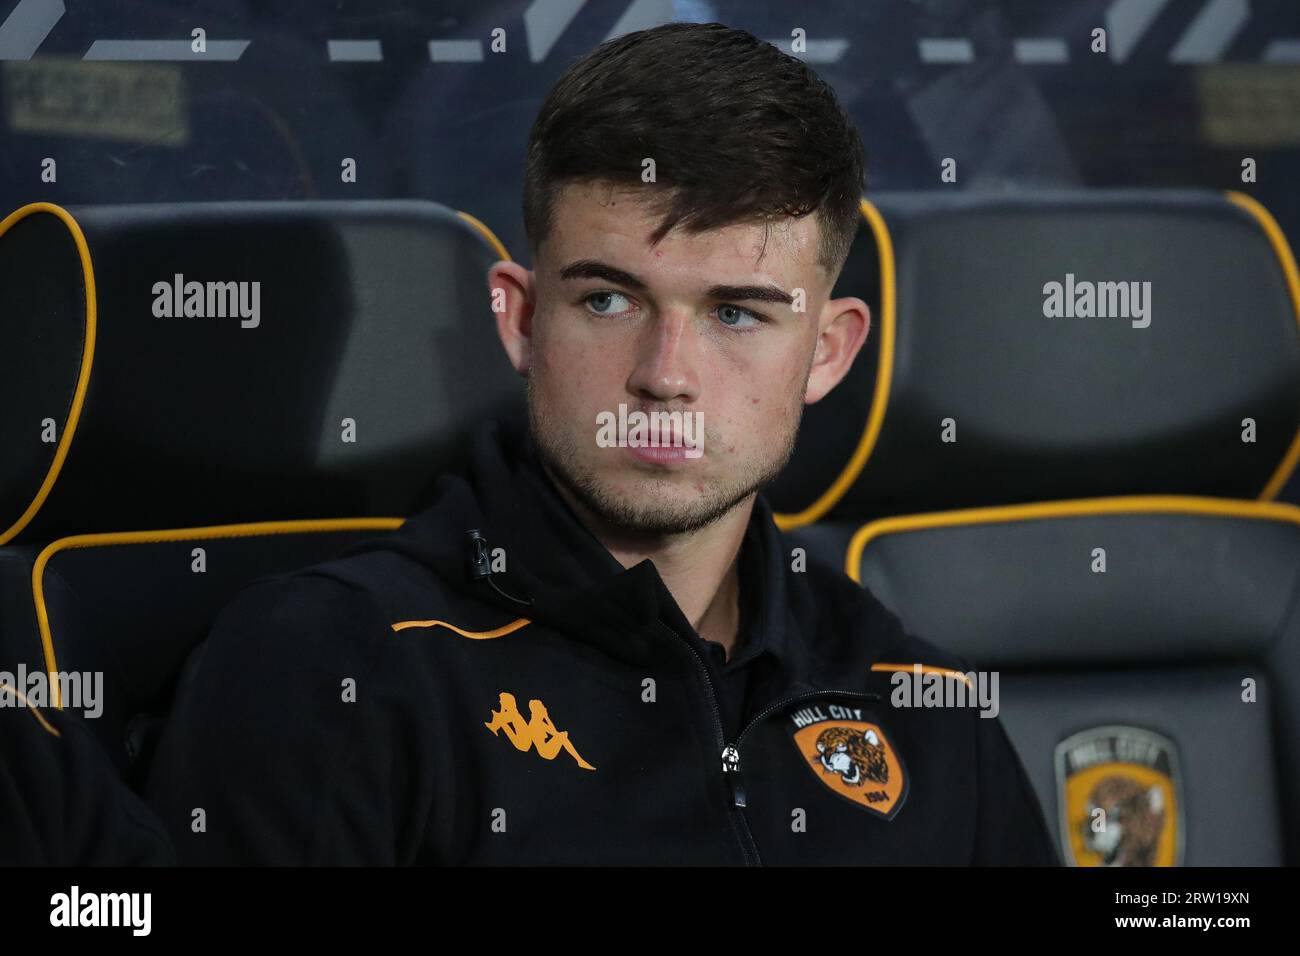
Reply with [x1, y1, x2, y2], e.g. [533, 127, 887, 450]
[0, 0, 1300, 258]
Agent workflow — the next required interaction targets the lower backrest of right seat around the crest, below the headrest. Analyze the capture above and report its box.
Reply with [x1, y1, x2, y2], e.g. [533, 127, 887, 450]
[846, 496, 1300, 866]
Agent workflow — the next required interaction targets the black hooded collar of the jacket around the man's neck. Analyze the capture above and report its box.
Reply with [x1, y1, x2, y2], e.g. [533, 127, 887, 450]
[384, 415, 800, 662]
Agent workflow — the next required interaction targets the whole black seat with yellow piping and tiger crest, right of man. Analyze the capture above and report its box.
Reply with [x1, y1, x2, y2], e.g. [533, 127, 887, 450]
[774, 193, 1300, 865]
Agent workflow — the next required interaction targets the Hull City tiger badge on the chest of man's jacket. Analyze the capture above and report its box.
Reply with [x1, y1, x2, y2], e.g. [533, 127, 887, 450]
[789, 702, 907, 819]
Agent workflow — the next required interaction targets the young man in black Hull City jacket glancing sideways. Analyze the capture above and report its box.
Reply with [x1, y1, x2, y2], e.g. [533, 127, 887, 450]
[148, 23, 1057, 864]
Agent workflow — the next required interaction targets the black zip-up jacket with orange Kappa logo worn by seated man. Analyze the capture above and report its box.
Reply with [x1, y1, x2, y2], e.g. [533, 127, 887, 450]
[146, 418, 1058, 865]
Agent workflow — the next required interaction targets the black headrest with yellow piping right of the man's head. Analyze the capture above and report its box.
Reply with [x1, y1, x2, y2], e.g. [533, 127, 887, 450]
[771, 190, 1300, 528]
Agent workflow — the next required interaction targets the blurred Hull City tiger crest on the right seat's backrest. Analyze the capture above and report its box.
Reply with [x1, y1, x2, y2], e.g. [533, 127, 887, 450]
[1056, 726, 1183, 866]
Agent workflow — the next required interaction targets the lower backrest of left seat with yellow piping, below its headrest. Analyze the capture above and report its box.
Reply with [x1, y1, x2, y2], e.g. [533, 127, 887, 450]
[0, 518, 402, 786]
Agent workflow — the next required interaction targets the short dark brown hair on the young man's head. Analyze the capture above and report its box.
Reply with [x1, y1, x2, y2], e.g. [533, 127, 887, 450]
[524, 23, 866, 277]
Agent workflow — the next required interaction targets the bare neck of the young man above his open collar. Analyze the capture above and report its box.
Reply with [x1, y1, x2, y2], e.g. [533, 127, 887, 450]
[547, 470, 754, 659]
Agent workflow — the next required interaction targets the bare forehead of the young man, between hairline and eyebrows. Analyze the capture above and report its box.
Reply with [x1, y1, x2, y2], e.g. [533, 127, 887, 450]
[546, 182, 820, 284]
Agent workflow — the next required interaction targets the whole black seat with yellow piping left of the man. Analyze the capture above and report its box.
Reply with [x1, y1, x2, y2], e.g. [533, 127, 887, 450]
[0, 200, 523, 790]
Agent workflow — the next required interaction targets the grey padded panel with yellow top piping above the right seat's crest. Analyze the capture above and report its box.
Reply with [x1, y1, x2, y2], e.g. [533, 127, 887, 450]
[845, 496, 1300, 669]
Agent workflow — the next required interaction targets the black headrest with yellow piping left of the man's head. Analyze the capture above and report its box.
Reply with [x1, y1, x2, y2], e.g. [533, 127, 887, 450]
[0, 200, 523, 544]
